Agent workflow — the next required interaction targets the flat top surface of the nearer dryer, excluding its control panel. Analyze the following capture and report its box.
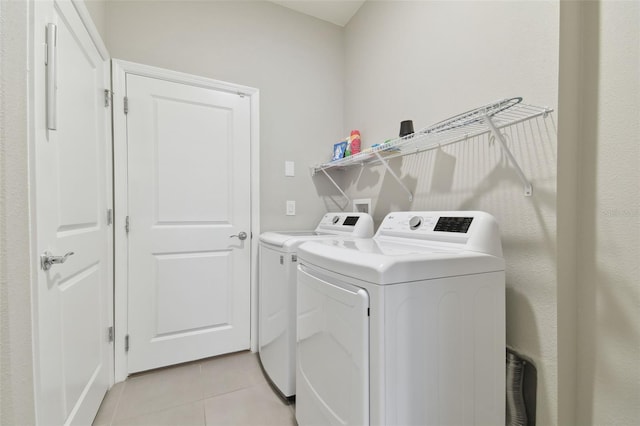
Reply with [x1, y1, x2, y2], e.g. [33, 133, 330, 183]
[298, 239, 505, 285]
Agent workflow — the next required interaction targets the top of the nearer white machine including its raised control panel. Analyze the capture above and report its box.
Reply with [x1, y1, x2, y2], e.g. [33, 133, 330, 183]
[298, 211, 505, 285]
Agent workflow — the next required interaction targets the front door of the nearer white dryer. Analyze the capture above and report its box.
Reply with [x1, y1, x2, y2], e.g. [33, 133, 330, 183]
[296, 265, 369, 426]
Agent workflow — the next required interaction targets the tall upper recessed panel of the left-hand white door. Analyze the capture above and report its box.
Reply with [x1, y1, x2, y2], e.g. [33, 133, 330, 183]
[52, 9, 100, 232]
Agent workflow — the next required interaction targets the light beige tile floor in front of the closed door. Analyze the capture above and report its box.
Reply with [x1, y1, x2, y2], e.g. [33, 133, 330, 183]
[93, 352, 296, 426]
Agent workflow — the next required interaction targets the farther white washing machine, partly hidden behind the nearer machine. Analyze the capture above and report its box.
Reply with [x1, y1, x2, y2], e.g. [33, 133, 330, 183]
[258, 213, 373, 397]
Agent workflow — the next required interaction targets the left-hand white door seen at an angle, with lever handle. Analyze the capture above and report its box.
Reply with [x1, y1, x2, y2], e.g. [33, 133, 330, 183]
[33, 1, 113, 425]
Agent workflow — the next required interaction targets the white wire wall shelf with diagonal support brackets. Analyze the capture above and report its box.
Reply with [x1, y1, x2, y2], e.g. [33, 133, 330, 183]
[312, 97, 553, 201]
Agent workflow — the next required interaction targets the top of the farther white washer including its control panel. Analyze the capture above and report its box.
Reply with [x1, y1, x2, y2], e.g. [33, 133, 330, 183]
[260, 212, 373, 249]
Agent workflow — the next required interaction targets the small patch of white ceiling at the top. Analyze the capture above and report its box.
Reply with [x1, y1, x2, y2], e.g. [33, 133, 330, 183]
[270, 0, 365, 27]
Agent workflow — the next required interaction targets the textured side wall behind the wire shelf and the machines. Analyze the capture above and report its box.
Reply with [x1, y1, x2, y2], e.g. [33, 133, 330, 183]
[334, 1, 559, 425]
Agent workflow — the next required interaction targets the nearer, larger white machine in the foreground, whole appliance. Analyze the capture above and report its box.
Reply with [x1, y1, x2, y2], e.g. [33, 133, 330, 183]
[296, 211, 505, 426]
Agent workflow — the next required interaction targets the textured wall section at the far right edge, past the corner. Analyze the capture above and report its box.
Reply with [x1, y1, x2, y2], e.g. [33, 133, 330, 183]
[575, 1, 640, 425]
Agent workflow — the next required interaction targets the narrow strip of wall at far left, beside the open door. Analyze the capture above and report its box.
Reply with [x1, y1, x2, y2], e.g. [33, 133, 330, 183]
[0, 1, 35, 425]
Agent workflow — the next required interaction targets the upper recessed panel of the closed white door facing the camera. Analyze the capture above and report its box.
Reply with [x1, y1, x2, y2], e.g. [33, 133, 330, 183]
[154, 98, 233, 224]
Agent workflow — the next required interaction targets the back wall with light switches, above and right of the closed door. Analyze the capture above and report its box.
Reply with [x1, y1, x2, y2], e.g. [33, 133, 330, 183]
[106, 1, 344, 231]
